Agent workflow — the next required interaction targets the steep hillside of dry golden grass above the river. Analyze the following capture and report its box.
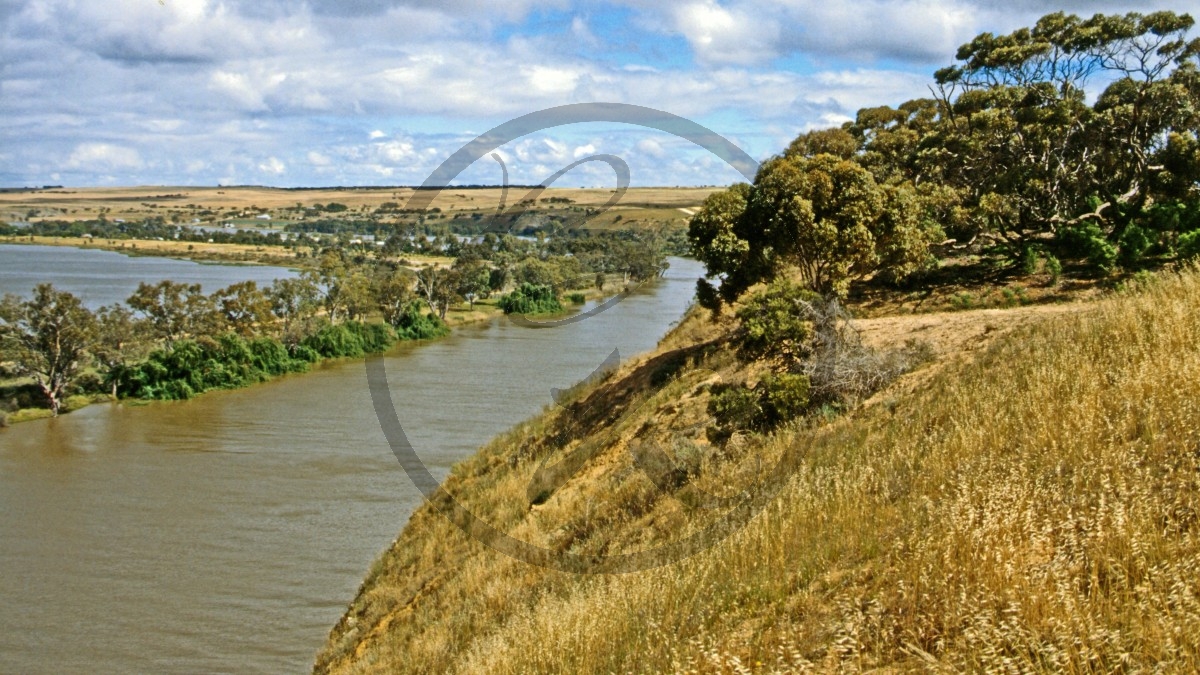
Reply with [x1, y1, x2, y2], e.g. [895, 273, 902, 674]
[316, 266, 1200, 673]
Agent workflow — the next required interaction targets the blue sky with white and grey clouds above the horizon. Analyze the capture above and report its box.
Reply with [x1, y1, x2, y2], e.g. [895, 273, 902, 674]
[0, 0, 1200, 187]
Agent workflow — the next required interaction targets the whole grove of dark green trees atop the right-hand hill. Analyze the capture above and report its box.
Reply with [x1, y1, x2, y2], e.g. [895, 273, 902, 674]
[689, 12, 1200, 306]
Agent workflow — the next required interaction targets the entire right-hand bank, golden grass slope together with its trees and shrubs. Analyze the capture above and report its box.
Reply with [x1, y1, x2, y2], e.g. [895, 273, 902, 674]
[314, 12, 1200, 674]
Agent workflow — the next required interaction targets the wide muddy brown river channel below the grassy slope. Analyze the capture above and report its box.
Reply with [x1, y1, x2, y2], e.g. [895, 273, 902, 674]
[0, 249, 702, 673]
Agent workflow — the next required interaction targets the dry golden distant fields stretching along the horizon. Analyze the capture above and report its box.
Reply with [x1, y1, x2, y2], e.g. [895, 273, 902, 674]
[0, 186, 718, 228]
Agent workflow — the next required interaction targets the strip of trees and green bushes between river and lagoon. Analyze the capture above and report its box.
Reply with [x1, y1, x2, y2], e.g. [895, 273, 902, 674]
[0, 231, 666, 424]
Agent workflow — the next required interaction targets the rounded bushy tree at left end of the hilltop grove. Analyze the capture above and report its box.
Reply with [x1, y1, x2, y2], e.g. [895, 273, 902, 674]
[688, 154, 941, 301]
